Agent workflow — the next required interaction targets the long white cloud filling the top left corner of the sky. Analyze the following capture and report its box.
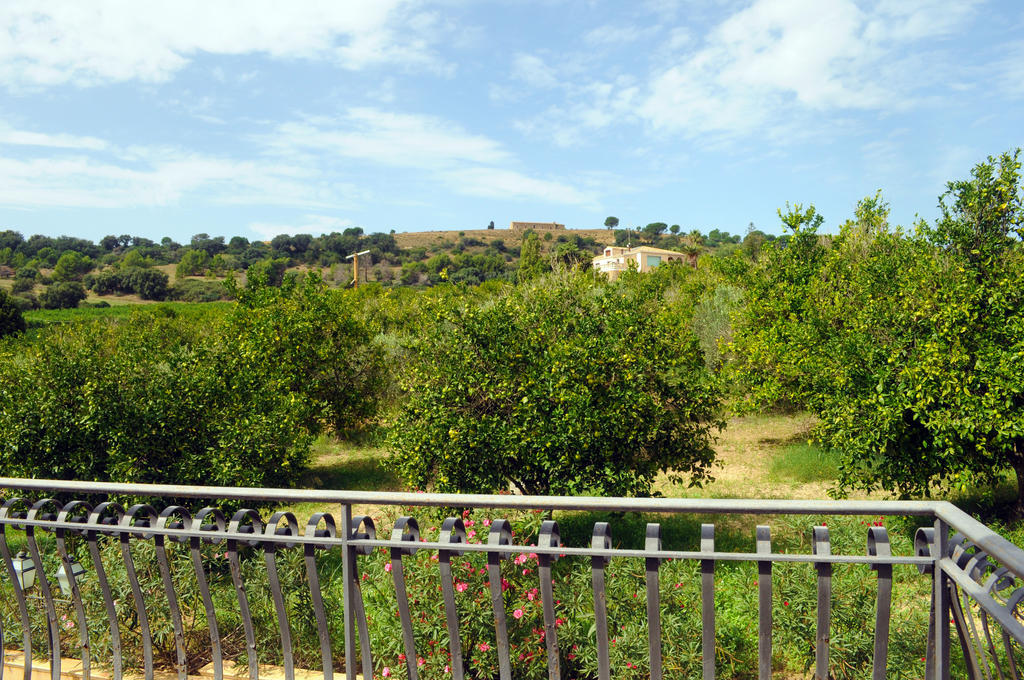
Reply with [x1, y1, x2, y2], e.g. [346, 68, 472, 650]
[0, 0, 444, 87]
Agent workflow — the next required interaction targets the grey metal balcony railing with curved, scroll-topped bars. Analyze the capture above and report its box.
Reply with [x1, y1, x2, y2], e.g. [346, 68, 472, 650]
[0, 478, 1024, 680]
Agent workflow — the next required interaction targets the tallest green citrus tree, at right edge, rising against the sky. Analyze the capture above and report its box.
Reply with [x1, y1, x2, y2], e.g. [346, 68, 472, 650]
[736, 153, 1024, 516]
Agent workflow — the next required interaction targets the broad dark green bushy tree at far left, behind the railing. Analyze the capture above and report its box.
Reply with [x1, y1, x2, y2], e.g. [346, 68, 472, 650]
[0, 311, 311, 486]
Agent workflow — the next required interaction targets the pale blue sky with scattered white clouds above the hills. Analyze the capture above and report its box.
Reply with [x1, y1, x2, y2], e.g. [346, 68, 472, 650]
[0, 0, 1024, 242]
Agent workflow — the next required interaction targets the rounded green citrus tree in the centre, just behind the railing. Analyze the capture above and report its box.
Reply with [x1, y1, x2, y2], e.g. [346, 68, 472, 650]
[389, 273, 721, 495]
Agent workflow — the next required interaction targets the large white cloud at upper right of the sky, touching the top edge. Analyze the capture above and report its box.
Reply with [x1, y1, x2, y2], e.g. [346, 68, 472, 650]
[638, 0, 974, 137]
